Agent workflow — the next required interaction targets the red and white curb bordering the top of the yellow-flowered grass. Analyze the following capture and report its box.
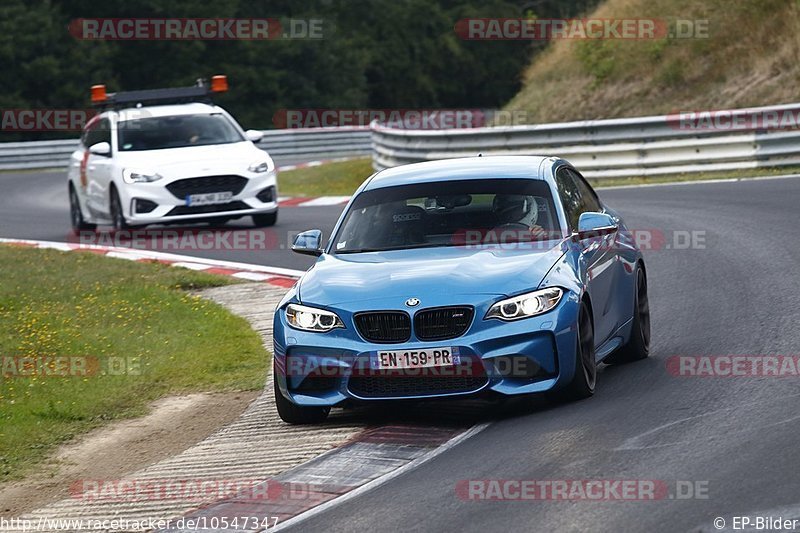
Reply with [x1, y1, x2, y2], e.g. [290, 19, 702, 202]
[0, 238, 303, 288]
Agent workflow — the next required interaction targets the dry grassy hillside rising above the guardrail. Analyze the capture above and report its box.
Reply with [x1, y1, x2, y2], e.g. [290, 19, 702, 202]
[506, 0, 800, 124]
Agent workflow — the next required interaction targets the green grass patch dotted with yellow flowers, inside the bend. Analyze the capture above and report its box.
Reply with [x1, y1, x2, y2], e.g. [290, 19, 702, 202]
[0, 245, 269, 481]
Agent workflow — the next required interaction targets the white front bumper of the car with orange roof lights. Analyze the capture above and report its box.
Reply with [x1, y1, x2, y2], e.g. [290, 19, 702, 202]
[120, 172, 278, 225]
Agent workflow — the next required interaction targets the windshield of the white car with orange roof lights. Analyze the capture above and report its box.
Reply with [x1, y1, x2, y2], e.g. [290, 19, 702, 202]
[119, 113, 244, 152]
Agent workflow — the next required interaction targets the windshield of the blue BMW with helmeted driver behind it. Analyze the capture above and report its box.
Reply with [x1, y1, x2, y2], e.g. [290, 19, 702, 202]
[332, 178, 561, 254]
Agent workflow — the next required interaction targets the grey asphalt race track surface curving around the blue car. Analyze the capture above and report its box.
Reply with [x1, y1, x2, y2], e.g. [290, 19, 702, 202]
[0, 169, 800, 531]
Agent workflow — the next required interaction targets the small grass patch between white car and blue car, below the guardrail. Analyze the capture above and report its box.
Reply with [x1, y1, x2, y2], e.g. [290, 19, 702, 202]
[278, 158, 375, 196]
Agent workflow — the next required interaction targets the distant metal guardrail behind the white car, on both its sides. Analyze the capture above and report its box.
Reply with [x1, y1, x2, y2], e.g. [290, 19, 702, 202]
[0, 127, 371, 170]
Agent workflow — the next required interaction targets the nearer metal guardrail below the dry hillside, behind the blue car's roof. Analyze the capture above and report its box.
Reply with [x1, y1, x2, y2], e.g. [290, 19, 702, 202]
[370, 104, 800, 178]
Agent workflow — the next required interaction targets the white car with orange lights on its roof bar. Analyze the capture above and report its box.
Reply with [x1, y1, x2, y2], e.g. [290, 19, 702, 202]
[68, 76, 278, 231]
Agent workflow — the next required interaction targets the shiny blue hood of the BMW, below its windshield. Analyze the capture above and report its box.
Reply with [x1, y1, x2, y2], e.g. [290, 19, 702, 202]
[299, 241, 565, 306]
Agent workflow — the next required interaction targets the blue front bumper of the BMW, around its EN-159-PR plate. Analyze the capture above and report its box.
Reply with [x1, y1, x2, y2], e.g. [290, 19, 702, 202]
[274, 292, 578, 406]
